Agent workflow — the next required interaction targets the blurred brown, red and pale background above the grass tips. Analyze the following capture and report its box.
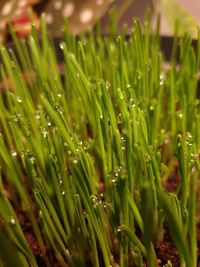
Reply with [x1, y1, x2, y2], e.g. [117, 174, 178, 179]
[0, 0, 200, 43]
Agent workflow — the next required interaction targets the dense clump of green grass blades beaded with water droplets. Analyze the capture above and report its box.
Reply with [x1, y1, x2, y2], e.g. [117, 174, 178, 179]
[0, 12, 200, 267]
